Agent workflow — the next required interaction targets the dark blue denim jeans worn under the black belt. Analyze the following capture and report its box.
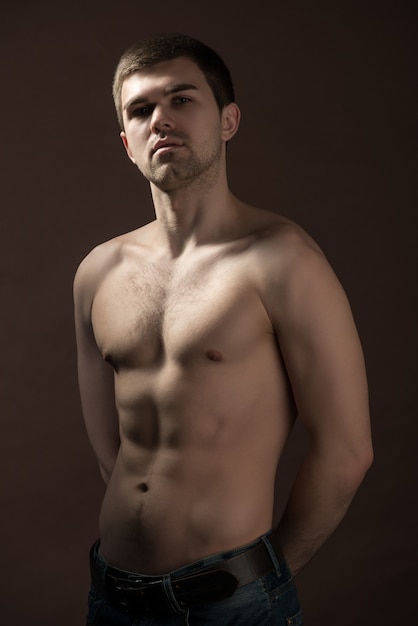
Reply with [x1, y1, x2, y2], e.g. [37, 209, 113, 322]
[87, 534, 302, 626]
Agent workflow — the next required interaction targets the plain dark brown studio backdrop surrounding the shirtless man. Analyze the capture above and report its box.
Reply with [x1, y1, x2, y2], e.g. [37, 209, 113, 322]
[0, 0, 418, 626]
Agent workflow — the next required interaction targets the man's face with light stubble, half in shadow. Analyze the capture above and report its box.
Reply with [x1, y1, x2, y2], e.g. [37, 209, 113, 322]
[121, 57, 235, 191]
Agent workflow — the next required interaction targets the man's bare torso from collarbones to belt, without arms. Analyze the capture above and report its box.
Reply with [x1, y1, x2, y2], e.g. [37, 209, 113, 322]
[88, 212, 294, 574]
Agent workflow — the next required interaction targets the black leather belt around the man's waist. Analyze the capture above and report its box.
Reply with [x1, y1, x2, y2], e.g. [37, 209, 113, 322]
[90, 533, 282, 615]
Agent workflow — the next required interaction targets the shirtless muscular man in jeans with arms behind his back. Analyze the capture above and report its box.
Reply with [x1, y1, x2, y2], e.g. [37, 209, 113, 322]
[75, 35, 372, 626]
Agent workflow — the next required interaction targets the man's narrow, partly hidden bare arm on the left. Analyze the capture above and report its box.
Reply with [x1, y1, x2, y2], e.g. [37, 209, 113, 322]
[74, 252, 120, 484]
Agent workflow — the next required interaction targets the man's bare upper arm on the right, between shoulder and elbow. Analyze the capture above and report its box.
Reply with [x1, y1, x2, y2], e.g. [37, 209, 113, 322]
[281, 270, 368, 446]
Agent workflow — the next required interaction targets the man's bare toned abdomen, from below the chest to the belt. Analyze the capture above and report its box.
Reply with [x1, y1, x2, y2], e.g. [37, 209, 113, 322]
[100, 352, 292, 575]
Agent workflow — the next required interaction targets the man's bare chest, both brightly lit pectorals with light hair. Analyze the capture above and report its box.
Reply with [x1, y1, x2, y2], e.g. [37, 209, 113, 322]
[92, 262, 269, 368]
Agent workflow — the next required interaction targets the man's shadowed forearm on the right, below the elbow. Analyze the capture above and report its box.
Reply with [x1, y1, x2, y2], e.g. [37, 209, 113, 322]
[277, 452, 368, 575]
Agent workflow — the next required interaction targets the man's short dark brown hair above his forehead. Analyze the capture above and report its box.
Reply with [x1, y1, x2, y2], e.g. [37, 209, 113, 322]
[113, 33, 235, 129]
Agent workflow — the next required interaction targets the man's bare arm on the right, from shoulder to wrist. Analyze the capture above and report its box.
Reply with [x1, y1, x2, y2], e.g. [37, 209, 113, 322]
[269, 227, 372, 574]
